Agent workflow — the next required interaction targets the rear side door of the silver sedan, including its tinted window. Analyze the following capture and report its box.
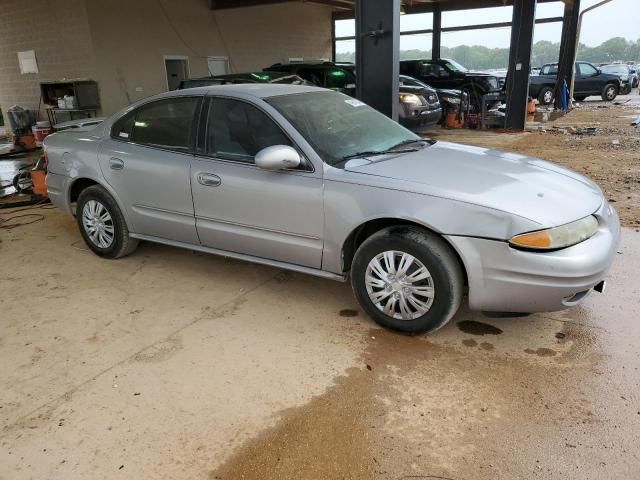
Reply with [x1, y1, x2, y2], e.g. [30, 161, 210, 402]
[99, 96, 202, 244]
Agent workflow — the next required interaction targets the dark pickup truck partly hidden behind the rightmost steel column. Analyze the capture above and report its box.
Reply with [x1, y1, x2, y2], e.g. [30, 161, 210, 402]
[529, 62, 620, 105]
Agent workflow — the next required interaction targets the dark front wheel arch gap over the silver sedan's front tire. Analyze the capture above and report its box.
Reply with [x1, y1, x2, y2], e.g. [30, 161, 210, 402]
[341, 217, 469, 285]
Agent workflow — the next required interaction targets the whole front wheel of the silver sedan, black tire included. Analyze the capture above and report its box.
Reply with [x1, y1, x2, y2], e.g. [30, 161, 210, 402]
[351, 226, 464, 334]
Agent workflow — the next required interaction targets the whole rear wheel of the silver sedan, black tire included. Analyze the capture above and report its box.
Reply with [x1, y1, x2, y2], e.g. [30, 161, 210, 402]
[76, 185, 138, 258]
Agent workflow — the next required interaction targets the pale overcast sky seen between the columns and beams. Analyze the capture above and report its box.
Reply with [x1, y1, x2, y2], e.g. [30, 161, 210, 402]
[336, 0, 640, 52]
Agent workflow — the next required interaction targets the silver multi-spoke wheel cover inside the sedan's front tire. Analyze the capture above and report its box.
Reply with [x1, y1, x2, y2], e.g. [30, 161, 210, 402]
[365, 250, 435, 320]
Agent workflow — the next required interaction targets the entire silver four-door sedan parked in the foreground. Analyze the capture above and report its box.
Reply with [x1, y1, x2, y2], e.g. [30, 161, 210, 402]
[45, 85, 620, 332]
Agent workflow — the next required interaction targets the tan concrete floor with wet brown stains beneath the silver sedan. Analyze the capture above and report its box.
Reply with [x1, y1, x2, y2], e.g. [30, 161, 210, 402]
[0, 209, 640, 480]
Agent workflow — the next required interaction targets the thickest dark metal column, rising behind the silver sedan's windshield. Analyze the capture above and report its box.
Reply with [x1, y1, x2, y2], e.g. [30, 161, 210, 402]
[356, 0, 400, 121]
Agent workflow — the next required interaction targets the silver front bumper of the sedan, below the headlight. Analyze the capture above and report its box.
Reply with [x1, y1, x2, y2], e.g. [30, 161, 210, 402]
[447, 201, 620, 313]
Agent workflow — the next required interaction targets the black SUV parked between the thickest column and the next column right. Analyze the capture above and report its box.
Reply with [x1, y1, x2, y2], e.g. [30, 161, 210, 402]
[400, 58, 500, 108]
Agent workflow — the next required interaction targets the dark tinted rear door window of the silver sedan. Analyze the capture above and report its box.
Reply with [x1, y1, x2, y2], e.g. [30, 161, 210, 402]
[120, 97, 200, 152]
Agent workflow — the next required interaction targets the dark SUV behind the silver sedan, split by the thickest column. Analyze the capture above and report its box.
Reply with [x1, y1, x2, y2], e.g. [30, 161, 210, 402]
[265, 62, 442, 130]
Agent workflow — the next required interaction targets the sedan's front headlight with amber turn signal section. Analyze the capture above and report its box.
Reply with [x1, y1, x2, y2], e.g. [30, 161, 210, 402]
[509, 215, 598, 250]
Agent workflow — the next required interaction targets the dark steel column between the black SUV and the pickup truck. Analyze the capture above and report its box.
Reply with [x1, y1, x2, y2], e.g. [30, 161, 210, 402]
[505, 0, 536, 130]
